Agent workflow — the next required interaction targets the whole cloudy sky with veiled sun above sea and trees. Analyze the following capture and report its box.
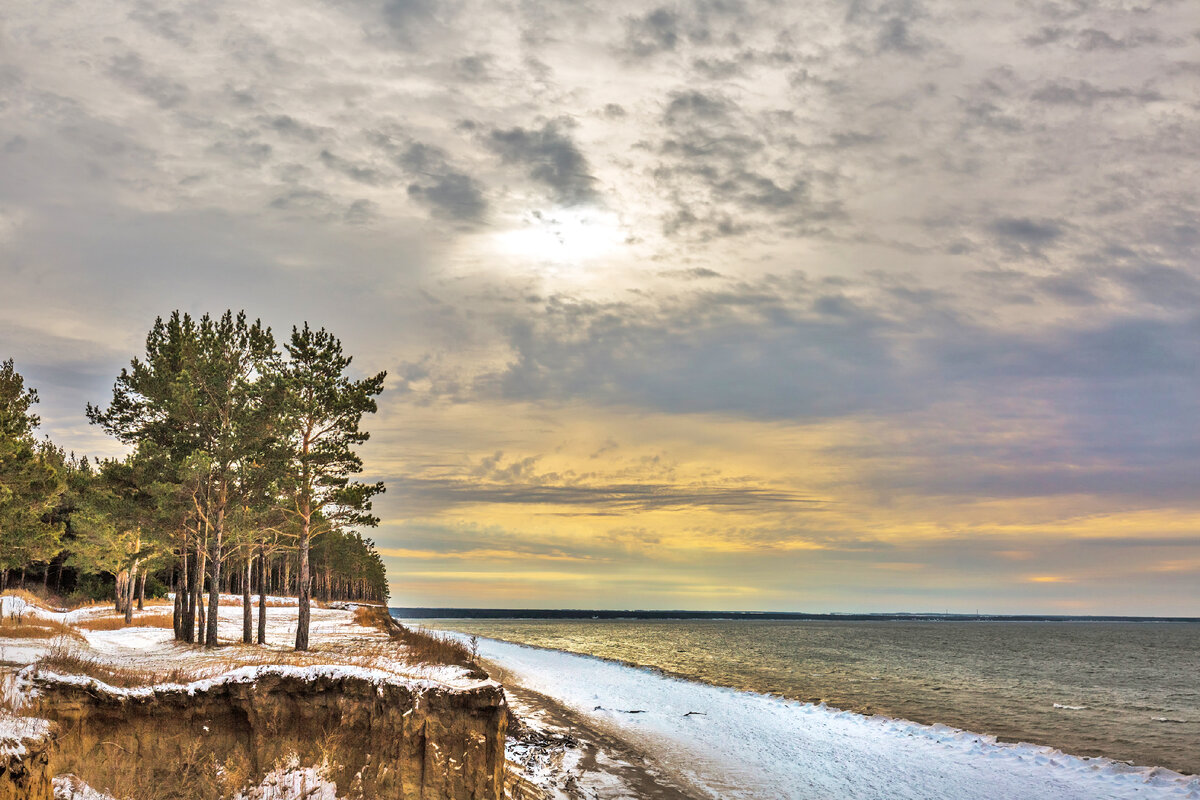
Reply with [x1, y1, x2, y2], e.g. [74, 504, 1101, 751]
[0, 0, 1200, 615]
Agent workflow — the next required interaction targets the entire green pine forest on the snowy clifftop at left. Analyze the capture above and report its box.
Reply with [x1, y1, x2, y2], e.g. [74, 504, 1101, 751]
[0, 311, 388, 650]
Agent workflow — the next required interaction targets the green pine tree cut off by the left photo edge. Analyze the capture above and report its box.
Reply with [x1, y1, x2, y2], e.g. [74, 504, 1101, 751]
[0, 359, 66, 583]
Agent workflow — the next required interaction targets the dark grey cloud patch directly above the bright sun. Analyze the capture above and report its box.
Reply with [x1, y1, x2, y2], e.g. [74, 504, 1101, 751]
[485, 119, 596, 205]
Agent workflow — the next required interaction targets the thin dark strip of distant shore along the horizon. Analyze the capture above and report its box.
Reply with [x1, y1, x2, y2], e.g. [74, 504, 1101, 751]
[389, 606, 1200, 624]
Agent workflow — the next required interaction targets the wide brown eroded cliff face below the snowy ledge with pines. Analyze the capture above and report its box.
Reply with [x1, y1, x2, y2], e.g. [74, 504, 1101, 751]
[28, 669, 506, 800]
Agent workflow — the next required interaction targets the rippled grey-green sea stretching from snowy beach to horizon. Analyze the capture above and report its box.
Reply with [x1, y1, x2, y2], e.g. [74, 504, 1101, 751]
[421, 619, 1200, 774]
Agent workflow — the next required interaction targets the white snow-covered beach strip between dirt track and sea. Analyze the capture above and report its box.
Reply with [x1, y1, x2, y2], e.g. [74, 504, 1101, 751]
[451, 637, 1200, 800]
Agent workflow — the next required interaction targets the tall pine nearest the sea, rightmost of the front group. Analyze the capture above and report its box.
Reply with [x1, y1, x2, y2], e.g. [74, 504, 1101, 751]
[280, 323, 388, 650]
